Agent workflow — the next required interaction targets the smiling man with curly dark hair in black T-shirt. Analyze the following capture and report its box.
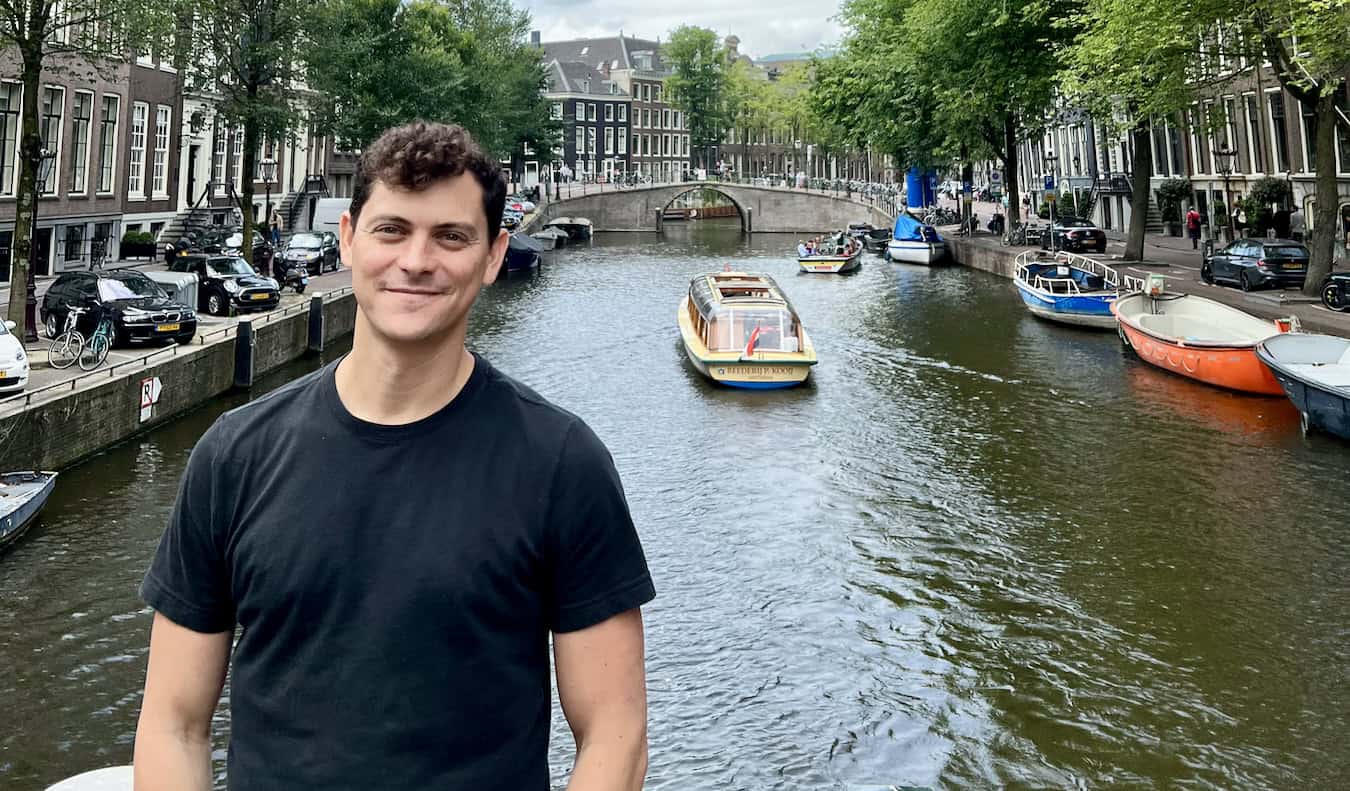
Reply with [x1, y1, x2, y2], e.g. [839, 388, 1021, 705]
[135, 121, 655, 791]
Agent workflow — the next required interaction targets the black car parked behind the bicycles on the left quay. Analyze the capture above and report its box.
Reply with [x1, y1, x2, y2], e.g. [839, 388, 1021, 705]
[39, 269, 197, 346]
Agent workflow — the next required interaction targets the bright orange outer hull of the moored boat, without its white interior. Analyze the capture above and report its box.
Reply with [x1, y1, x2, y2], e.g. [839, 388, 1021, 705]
[1119, 314, 1284, 396]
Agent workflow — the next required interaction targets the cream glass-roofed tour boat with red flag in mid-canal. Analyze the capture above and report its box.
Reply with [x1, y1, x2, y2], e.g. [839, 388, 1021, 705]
[678, 271, 815, 390]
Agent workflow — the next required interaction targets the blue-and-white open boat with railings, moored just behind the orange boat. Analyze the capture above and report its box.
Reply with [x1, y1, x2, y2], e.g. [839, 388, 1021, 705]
[1013, 251, 1143, 329]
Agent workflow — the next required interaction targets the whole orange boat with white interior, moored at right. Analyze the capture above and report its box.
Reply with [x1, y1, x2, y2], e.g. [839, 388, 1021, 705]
[1111, 293, 1288, 396]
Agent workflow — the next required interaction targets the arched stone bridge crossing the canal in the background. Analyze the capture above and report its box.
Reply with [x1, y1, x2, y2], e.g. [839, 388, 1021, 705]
[529, 181, 894, 234]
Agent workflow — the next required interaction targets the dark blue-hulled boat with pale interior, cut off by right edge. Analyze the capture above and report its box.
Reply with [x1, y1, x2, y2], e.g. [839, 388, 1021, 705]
[1257, 333, 1350, 440]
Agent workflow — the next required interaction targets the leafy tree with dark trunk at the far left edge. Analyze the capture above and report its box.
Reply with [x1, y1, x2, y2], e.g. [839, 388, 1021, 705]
[0, 0, 173, 320]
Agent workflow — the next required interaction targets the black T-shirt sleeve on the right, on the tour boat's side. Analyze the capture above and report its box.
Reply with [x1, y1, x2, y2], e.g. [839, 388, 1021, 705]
[548, 420, 656, 632]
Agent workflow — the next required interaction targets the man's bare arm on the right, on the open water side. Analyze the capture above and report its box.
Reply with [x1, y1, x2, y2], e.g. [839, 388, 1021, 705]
[554, 607, 647, 791]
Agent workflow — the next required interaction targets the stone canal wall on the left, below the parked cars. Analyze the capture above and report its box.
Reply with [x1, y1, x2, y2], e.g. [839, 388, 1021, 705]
[0, 289, 356, 470]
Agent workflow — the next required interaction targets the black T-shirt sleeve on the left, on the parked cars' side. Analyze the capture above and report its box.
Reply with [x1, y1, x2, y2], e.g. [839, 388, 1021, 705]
[140, 420, 235, 634]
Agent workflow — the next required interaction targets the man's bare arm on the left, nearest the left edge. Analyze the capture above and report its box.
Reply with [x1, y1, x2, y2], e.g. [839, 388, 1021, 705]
[135, 613, 234, 791]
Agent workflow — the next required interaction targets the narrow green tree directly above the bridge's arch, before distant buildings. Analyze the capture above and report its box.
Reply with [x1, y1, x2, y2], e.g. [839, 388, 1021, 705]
[662, 24, 730, 167]
